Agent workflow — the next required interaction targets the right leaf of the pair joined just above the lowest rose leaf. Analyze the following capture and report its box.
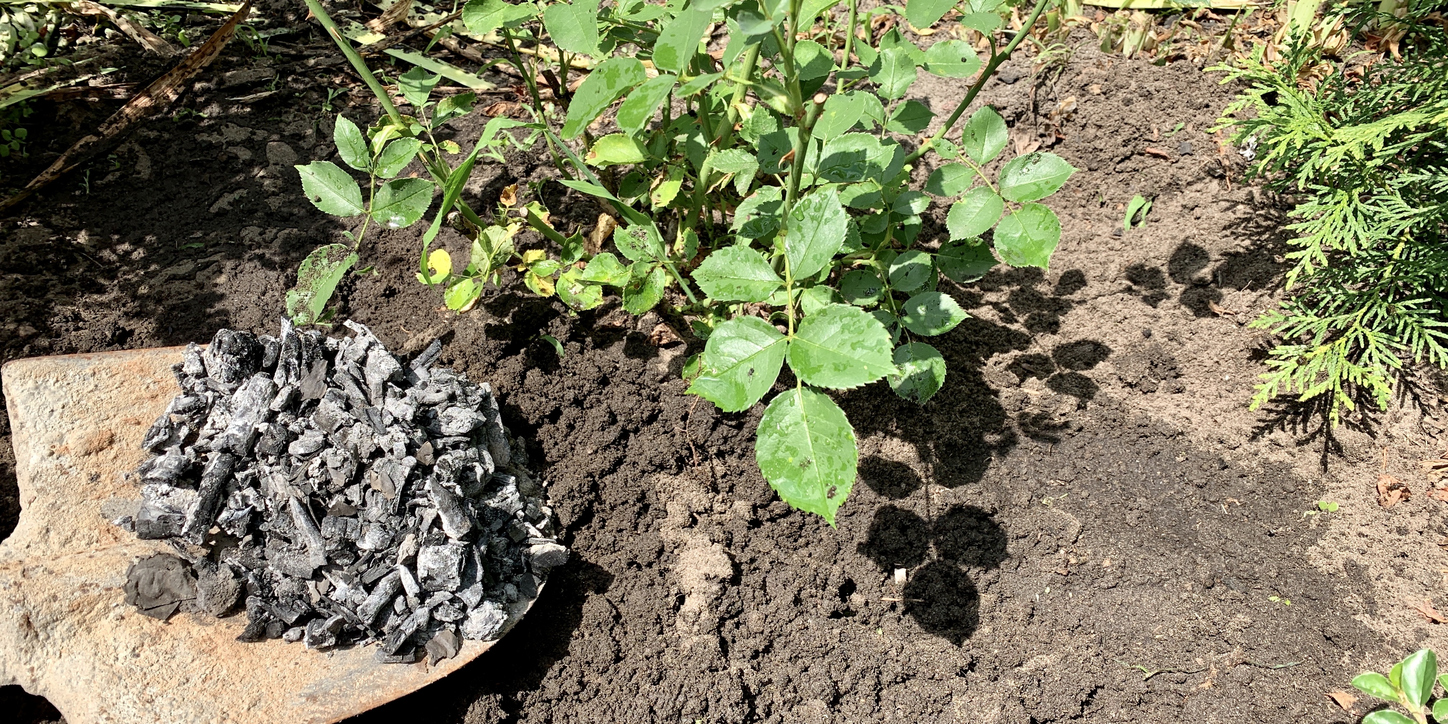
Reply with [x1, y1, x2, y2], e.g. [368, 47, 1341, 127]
[789, 304, 895, 390]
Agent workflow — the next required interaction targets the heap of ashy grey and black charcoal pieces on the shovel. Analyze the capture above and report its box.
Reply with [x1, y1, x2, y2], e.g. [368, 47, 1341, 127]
[117, 320, 568, 662]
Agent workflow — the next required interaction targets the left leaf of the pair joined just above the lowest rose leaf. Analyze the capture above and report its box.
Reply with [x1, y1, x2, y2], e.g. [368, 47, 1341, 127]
[688, 316, 788, 413]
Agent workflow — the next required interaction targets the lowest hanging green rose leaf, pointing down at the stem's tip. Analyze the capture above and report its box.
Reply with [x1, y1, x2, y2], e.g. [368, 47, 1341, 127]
[754, 387, 860, 526]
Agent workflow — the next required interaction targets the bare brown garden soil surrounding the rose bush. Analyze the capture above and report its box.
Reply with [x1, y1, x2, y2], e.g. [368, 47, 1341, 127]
[0, 15, 1448, 724]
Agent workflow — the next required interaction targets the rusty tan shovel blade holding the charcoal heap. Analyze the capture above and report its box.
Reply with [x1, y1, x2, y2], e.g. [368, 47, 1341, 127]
[0, 348, 527, 724]
